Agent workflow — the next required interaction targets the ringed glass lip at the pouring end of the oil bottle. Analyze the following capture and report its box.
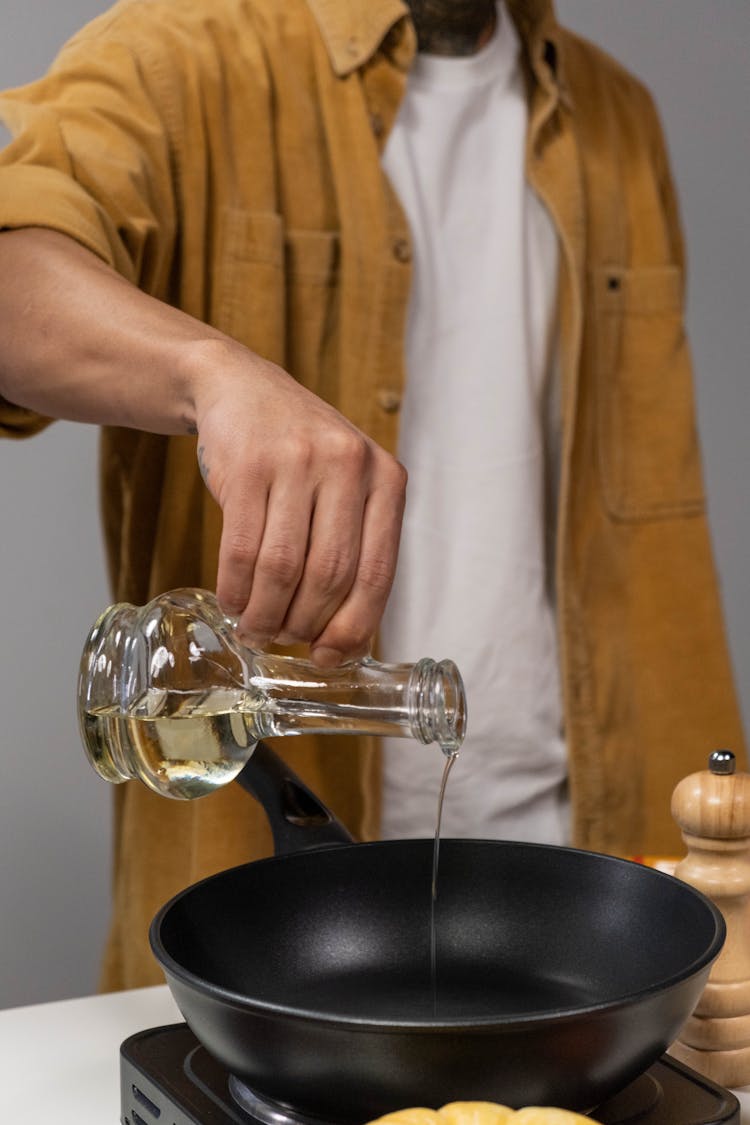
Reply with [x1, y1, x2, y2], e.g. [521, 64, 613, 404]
[408, 659, 467, 758]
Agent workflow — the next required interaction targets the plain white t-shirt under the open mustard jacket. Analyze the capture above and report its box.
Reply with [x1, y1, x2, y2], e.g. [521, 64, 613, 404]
[381, 7, 569, 843]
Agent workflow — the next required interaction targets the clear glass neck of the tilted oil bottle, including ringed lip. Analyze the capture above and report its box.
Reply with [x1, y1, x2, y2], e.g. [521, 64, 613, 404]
[250, 653, 467, 755]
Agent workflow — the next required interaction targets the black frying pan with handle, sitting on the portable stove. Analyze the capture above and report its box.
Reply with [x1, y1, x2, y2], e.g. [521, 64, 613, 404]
[151, 745, 724, 1123]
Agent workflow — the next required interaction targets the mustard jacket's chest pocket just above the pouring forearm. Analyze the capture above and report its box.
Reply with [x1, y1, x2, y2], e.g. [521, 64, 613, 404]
[211, 207, 340, 390]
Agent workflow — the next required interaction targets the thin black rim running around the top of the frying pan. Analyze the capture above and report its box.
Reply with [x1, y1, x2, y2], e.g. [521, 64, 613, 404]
[148, 837, 726, 1034]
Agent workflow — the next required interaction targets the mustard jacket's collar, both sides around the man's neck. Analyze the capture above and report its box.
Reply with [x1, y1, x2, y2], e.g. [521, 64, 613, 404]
[307, 0, 564, 92]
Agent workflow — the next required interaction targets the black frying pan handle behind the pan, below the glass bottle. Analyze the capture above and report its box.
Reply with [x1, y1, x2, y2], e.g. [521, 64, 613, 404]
[235, 743, 354, 855]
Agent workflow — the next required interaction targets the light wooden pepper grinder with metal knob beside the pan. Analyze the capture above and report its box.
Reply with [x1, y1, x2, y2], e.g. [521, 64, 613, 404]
[670, 750, 750, 1087]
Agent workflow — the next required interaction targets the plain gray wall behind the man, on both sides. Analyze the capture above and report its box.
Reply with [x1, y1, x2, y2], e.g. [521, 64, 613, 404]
[0, 0, 750, 1007]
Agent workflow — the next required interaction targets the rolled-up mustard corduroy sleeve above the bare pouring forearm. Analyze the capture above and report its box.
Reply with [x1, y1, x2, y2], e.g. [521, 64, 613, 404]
[0, 6, 175, 437]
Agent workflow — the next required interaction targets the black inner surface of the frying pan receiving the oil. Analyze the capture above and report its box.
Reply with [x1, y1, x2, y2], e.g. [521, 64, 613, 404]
[155, 840, 717, 1024]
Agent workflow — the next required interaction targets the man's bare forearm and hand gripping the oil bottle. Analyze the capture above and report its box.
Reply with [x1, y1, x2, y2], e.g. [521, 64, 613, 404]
[0, 228, 406, 664]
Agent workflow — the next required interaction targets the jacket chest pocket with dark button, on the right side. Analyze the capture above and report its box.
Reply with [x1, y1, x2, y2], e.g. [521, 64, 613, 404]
[591, 267, 704, 521]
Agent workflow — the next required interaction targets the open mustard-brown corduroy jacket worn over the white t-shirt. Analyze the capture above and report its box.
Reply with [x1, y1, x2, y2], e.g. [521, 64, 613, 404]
[0, 0, 742, 988]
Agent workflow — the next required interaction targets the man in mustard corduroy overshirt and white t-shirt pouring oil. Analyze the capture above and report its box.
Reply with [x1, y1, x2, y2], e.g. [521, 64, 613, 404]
[0, 0, 741, 987]
